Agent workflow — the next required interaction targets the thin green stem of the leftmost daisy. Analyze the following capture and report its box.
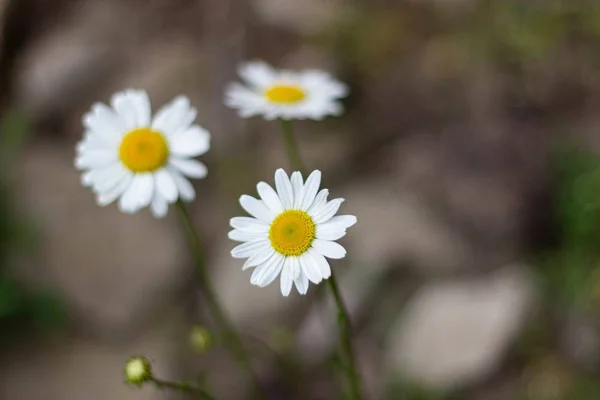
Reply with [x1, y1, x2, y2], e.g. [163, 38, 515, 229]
[176, 200, 264, 398]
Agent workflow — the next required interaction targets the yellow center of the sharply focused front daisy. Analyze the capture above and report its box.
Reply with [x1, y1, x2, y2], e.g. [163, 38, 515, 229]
[269, 210, 317, 256]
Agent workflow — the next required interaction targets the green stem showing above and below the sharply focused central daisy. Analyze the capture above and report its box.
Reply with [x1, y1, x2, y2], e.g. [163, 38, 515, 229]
[281, 120, 362, 400]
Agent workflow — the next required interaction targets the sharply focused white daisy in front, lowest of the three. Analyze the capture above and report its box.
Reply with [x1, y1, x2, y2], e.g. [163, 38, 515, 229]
[229, 169, 356, 296]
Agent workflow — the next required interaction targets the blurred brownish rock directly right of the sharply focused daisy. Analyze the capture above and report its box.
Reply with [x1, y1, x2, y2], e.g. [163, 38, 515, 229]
[340, 179, 469, 273]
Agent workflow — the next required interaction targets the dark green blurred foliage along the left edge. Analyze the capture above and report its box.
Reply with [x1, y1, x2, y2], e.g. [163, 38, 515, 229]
[0, 111, 65, 345]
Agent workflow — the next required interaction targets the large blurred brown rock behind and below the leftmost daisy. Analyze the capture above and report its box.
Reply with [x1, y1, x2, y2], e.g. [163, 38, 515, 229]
[18, 144, 191, 336]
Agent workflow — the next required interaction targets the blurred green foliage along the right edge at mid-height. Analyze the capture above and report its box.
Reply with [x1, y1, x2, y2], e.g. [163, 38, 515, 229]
[537, 146, 600, 308]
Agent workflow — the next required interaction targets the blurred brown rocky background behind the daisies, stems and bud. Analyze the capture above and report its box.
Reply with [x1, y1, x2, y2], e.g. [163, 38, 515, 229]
[0, 0, 600, 400]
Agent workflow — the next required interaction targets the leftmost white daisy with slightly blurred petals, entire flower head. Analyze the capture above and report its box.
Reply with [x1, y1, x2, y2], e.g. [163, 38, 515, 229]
[75, 90, 210, 218]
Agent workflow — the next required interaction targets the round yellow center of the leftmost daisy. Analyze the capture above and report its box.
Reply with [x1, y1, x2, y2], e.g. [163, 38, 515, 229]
[119, 128, 169, 173]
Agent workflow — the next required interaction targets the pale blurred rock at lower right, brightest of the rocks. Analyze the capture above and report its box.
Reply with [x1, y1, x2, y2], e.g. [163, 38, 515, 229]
[387, 266, 534, 388]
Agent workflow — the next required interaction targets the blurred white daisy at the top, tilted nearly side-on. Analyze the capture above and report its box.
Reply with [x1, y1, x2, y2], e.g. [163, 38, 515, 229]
[225, 61, 348, 120]
